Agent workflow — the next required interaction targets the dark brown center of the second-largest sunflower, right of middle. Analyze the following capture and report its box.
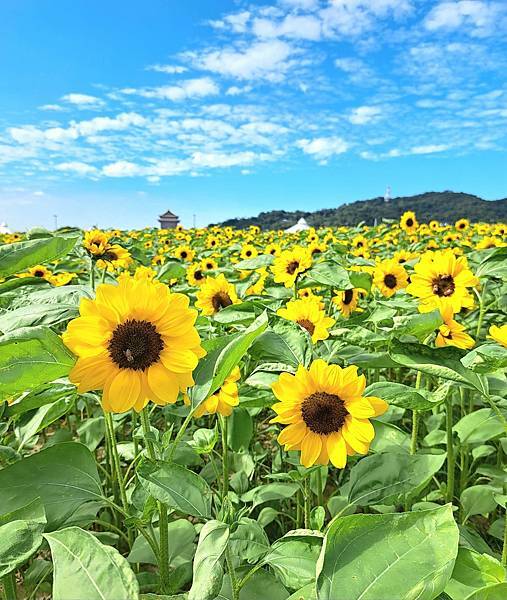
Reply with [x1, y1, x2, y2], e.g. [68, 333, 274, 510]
[301, 392, 349, 435]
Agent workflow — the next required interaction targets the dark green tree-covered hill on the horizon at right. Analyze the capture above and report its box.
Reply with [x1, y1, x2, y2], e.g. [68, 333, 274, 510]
[214, 192, 507, 229]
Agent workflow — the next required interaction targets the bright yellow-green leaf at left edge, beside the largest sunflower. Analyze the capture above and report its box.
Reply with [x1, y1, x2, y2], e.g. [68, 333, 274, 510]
[0, 327, 74, 399]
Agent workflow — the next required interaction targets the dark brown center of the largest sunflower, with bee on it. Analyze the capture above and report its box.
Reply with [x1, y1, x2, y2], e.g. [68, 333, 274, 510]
[107, 319, 164, 371]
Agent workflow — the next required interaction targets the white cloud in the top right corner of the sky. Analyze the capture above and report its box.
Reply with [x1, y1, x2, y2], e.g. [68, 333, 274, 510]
[424, 0, 507, 37]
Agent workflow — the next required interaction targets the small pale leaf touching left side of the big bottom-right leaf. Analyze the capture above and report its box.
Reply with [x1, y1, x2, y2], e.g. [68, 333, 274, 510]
[262, 529, 323, 589]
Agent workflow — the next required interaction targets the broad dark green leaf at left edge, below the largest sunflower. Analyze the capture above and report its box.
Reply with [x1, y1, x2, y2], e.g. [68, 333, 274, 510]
[0, 442, 103, 530]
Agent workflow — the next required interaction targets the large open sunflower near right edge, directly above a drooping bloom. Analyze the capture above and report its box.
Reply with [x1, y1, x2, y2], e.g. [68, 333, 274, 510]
[407, 250, 479, 313]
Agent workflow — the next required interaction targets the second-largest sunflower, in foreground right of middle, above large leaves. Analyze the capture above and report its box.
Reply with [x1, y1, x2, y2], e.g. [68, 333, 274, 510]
[271, 359, 387, 469]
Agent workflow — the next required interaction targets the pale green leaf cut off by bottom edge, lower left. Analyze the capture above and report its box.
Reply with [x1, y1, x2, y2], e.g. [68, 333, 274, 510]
[45, 527, 139, 600]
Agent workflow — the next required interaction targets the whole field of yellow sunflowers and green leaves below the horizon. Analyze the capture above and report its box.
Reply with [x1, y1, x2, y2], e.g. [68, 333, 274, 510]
[0, 212, 507, 600]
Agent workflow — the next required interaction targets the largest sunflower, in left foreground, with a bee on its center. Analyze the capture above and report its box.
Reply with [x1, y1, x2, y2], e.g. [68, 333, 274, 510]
[63, 277, 205, 413]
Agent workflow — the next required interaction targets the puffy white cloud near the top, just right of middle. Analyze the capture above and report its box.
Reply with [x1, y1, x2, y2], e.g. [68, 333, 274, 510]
[187, 40, 295, 81]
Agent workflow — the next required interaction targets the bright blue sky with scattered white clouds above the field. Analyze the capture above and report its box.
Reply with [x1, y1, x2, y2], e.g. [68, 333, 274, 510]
[0, 0, 507, 229]
